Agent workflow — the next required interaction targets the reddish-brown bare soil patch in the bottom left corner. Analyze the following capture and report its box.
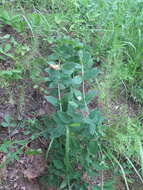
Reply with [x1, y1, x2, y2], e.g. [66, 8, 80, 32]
[0, 138, 46, 190]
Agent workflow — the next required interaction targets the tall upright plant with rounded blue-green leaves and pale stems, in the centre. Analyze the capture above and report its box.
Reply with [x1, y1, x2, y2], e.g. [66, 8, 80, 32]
[40, 37, 104, 188]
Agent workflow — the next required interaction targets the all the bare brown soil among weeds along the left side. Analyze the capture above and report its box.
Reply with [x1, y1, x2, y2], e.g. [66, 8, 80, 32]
[0, 25, 53, 190]
